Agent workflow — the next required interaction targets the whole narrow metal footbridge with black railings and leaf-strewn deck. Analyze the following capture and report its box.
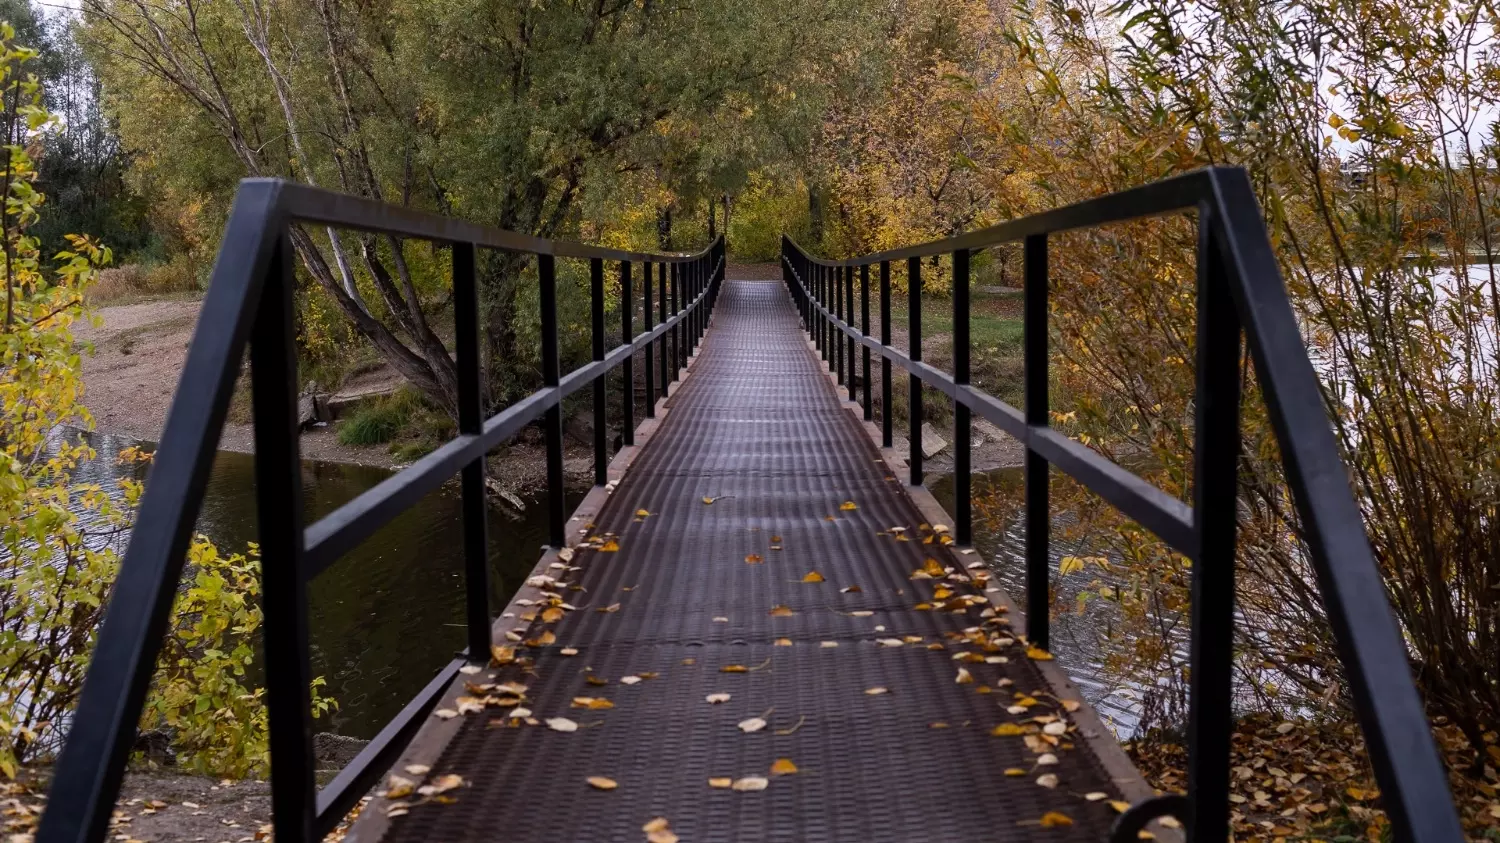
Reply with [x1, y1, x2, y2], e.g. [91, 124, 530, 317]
[38, 168, 1463, 843]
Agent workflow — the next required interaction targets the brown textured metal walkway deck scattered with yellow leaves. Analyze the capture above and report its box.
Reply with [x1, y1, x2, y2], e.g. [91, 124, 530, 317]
[368, 282, 1122, 843]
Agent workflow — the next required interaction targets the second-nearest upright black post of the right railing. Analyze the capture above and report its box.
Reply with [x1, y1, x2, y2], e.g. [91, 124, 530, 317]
[1022, 234, 1052, 650]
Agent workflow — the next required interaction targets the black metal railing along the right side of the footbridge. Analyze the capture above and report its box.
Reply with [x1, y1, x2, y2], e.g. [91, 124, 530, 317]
[782, 168, 1464, 843]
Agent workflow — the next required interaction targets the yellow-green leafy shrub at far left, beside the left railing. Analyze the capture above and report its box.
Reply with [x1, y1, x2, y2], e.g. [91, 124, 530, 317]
[0, 26, 332, 779]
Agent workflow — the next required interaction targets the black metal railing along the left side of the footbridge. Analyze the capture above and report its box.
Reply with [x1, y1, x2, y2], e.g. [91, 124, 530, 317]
[38, 179, 726, 843]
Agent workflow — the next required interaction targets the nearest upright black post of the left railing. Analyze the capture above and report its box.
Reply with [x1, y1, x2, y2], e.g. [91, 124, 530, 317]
[251, 231, 316, 843]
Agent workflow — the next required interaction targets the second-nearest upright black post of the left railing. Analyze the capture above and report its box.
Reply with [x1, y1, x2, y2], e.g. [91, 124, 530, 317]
[453, 243, 491, 662]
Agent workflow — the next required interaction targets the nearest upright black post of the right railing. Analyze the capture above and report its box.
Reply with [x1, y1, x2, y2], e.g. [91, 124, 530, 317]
[1182, 209, 1241, 842]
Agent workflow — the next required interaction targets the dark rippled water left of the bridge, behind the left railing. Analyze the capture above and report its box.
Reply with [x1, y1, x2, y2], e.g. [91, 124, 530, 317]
[80, 435, 558, 738]
